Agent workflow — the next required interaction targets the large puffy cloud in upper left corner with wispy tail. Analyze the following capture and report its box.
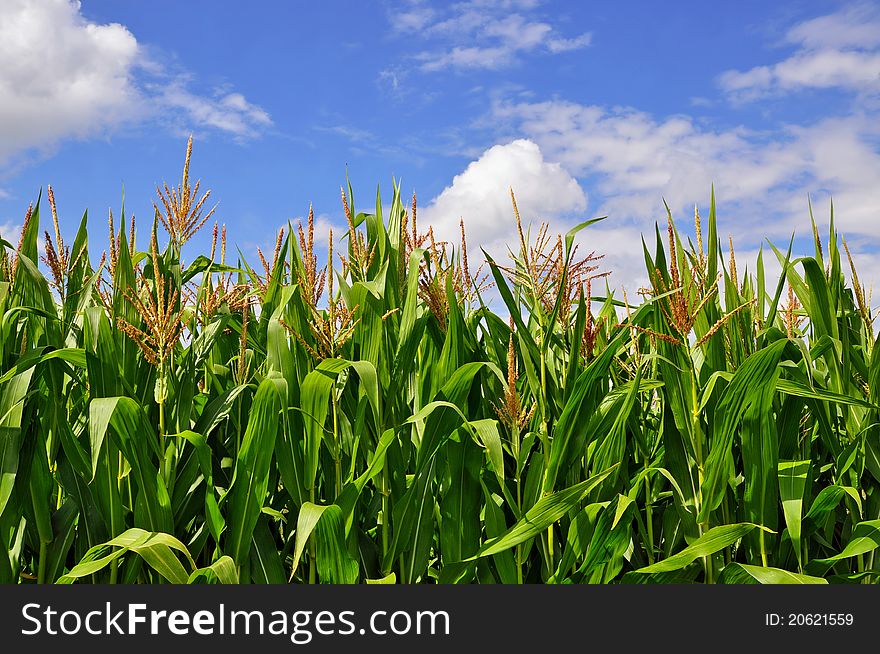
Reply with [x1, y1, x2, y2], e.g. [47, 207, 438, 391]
[0, 0, 271, 169]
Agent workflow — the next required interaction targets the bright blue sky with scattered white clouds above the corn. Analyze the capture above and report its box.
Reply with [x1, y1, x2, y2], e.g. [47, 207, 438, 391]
[0, 0, 880, 296]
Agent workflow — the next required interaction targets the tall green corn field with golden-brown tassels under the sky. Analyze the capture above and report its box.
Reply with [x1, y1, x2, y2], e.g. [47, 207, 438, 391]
[0, 140, 880, 584]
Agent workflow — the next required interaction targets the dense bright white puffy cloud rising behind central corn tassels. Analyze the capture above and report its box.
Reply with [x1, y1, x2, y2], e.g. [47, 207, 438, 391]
[418, 139, 587, 258]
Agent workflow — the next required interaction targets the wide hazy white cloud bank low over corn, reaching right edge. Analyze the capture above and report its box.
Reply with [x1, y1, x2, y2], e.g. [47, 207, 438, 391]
[478, 101, 880, 298]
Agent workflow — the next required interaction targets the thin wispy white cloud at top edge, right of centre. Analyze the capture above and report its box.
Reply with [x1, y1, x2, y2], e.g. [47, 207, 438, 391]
[389, 0, 591, 72]
